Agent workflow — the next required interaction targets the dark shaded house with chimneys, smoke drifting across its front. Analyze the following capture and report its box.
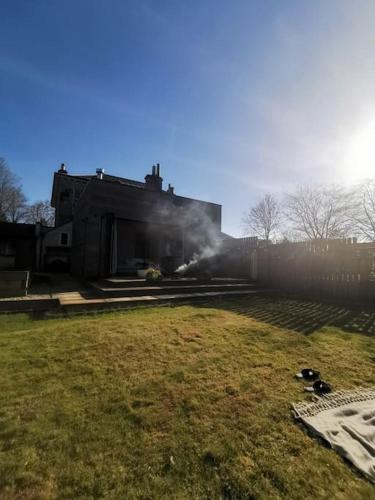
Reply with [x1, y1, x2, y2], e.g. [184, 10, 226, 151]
[51, 164, 221, 278]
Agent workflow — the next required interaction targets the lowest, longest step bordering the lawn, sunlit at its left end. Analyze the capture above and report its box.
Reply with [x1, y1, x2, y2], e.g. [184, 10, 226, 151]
[59, 289, 265, 313]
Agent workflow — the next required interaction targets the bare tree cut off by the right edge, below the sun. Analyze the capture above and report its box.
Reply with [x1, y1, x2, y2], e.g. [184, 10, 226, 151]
[351, 180, 375, 241]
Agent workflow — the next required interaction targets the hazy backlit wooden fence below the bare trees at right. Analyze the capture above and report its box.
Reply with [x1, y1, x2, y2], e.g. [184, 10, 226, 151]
[252, 239, 375, 305]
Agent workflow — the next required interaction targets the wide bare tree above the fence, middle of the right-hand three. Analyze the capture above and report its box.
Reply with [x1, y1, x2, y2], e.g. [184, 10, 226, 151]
[284, 186, 353, 240]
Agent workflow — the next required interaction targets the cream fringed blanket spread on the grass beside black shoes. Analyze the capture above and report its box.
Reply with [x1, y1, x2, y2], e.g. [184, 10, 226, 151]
[293, 387, 375, 483]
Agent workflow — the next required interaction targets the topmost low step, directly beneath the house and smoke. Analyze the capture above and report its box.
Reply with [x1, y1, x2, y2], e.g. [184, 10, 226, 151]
[97, 276, 249, 289]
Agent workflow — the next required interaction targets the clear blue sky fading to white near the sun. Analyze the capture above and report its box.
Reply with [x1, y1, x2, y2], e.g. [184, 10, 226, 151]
[0, 0, 375, 235]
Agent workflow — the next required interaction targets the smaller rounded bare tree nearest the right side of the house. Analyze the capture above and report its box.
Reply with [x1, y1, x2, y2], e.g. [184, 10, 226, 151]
[243, 193, 281, 241]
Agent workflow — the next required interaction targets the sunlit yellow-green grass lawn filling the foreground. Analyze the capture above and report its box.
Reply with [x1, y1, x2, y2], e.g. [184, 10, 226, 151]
[0, 298, 375, 499]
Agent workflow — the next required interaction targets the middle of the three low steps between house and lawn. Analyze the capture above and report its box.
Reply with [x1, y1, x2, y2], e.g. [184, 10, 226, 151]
[91, 282, 254, 297]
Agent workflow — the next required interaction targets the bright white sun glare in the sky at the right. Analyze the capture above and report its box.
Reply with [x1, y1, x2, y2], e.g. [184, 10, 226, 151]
[344, 119, 375, 182]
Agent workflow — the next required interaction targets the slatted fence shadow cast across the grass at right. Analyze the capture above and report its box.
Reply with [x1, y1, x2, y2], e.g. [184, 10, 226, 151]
[187, 294, 375, 336]
